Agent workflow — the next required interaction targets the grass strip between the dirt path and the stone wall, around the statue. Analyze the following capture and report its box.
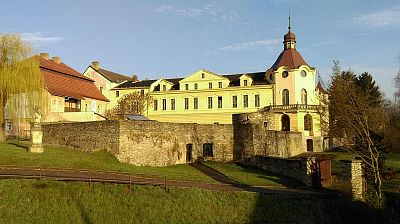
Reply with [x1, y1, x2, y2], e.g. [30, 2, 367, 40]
[0, 141, 215, 183]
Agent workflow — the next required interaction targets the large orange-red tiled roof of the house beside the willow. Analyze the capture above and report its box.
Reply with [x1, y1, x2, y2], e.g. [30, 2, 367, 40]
[36, 56, 108, 101]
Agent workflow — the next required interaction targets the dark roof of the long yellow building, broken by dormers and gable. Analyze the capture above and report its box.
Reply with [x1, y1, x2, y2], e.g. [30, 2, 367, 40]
[114, 72, 269, 91]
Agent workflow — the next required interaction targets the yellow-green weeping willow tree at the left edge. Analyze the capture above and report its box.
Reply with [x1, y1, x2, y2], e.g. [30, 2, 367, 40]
[0, 33, 43, 143]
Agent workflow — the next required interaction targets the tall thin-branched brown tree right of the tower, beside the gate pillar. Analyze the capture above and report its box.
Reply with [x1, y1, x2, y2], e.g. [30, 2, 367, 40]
[329, 62, 385, 208]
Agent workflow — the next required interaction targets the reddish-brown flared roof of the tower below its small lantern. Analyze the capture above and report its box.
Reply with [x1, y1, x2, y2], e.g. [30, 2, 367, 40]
[271, 48, 308, 70]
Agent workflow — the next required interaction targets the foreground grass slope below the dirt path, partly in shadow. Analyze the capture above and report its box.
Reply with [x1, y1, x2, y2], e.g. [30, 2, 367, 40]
[0, 179, 396, 223]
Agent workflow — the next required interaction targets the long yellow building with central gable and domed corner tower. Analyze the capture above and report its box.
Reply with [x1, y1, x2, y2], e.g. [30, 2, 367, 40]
[108, 21, 324, 140]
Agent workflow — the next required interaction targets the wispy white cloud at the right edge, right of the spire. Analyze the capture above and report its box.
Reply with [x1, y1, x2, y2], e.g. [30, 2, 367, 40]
[350, 7, 400, 28]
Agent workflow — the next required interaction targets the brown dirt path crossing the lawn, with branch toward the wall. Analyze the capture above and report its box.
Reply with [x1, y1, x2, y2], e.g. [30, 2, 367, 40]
[0, 165, 326, 196]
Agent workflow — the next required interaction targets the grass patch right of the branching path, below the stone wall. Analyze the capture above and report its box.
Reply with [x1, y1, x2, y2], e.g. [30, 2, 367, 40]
[203, 161, 303, 187]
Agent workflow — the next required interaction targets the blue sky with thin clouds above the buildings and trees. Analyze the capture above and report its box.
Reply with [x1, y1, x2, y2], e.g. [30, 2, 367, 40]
[0, 0, 400, 98]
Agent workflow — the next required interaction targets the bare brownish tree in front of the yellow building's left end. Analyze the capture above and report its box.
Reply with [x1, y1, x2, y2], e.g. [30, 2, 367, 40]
[106, 92, 151, 120]
